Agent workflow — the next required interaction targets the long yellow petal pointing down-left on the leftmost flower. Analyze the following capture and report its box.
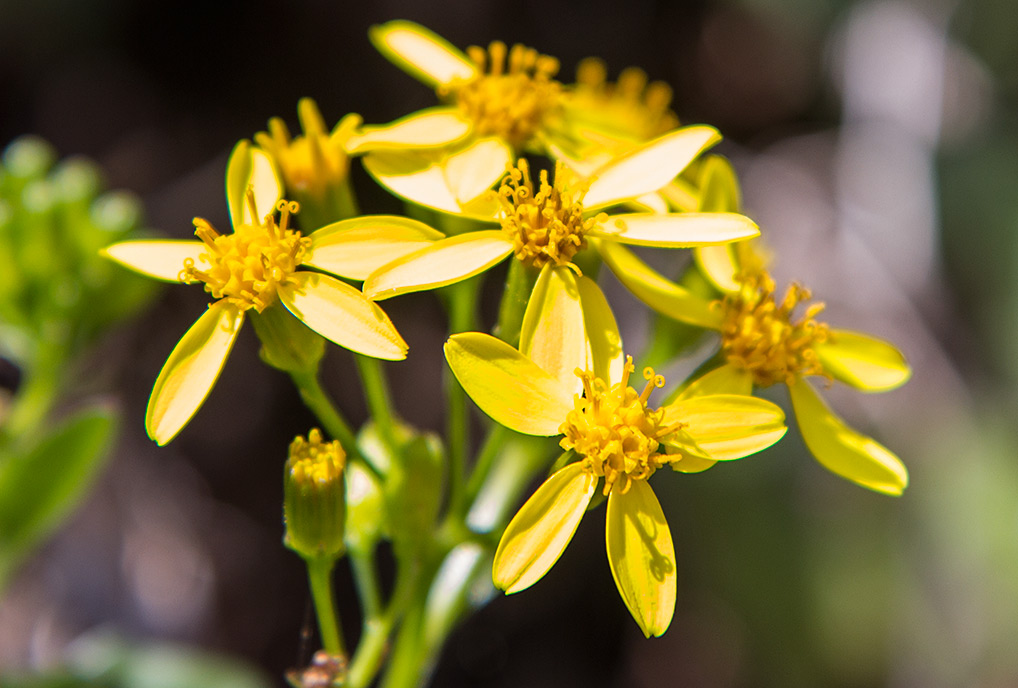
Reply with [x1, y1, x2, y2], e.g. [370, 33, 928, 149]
[145, 299, 244, 446]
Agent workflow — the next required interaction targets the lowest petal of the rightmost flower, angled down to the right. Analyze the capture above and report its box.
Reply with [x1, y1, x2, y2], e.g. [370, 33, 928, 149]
[788, 380, 908, 496]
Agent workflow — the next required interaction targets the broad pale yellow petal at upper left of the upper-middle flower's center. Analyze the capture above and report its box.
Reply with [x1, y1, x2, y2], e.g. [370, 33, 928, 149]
[363, 138, 512, 216]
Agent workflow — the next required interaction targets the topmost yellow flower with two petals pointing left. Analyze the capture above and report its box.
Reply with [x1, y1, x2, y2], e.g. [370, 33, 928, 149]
[348, 20, 562, 153]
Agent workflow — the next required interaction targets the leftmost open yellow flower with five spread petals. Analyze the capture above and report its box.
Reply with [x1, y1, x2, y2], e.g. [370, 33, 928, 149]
[103, 141, 441, 445]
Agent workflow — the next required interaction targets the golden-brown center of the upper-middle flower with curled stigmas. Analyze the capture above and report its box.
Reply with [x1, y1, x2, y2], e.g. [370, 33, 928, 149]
[498, 158, 608, 268]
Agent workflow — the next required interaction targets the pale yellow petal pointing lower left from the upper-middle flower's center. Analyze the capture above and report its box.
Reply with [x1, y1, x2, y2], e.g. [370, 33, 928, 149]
[364, 230, 512, 299]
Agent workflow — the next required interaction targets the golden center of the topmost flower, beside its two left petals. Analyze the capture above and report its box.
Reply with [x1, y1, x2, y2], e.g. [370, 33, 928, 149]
[439, 41, 562, 151]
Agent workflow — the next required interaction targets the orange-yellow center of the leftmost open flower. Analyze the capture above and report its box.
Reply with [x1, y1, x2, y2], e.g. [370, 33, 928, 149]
[180, 189, 310, 312]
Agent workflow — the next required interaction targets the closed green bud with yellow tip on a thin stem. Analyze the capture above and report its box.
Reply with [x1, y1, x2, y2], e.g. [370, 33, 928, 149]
[283, 428, 346, 559]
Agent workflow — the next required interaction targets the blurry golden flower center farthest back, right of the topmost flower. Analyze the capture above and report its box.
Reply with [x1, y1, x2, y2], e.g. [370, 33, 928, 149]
[571, 58, 679, 140]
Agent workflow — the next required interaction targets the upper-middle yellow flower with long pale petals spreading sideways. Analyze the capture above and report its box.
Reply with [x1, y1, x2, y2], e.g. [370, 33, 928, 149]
[363, 126, 759, 313]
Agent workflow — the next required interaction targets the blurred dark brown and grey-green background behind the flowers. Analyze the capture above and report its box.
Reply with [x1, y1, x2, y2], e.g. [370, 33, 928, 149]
[0, 0, 1018, 688]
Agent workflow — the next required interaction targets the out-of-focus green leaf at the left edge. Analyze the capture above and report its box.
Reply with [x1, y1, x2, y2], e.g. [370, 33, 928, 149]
[0, 407, 117, 587]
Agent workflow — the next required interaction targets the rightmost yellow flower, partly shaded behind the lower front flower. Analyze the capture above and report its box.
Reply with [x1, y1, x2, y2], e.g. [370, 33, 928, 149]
[604, 158, 911, 495]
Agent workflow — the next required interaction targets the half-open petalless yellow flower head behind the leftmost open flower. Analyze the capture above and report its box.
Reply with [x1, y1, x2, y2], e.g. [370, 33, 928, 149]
[255, 98, 360, 203]
